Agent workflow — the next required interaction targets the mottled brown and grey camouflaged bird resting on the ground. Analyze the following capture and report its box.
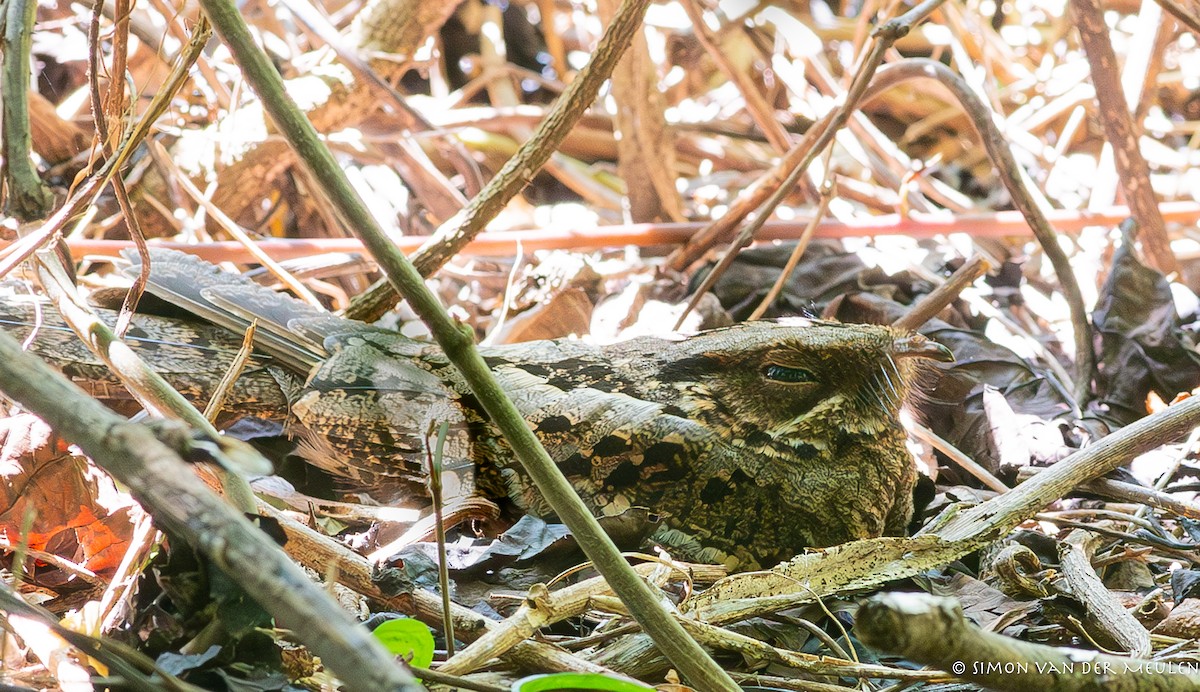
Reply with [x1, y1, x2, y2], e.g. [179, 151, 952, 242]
[7, 251, 950, 568]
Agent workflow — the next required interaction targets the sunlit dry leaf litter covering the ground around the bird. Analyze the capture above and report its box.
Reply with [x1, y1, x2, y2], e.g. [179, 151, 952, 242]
[7, 0, 1200, 688]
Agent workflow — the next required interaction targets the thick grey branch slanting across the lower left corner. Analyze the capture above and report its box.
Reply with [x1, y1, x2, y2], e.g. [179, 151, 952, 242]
[0, 326, 420, 690]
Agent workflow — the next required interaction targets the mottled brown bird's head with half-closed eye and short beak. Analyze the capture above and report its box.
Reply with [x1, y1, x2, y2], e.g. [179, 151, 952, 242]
[662, 319, 953, 447]
